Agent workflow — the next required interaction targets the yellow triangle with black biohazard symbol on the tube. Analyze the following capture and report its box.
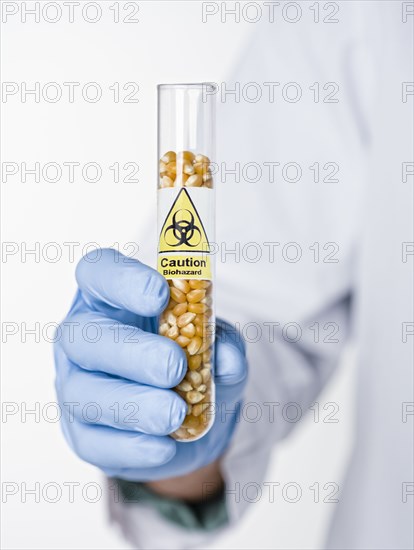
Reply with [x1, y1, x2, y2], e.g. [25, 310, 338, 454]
[159, 189, 210, 253]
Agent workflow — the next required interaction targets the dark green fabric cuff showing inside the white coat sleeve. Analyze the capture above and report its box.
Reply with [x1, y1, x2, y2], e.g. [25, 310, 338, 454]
[116, 479, 229, 531]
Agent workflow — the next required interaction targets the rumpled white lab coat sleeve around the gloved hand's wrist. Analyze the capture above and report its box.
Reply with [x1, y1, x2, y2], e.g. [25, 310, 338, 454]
[108, 298, 349, 550]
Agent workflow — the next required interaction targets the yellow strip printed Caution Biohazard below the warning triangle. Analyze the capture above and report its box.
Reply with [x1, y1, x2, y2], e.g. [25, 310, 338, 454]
[158, 254, 211, 279]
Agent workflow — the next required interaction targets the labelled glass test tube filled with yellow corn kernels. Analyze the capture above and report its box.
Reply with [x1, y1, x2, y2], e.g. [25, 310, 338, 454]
[157, 83, 216, 442]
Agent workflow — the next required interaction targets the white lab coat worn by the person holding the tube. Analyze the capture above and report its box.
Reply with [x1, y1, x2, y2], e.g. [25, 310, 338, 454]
[111, 1, 414, 550]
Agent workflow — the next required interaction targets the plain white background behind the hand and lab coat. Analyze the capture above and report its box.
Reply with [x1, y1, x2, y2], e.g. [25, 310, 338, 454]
[1, 1, 353, 549]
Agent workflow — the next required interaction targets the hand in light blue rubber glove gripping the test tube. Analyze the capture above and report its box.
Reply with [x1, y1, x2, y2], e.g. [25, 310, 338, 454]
[55, 249, 247, 481]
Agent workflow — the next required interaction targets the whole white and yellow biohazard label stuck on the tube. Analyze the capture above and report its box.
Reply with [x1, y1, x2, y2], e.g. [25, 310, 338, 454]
[158, 188, 213, 279]
